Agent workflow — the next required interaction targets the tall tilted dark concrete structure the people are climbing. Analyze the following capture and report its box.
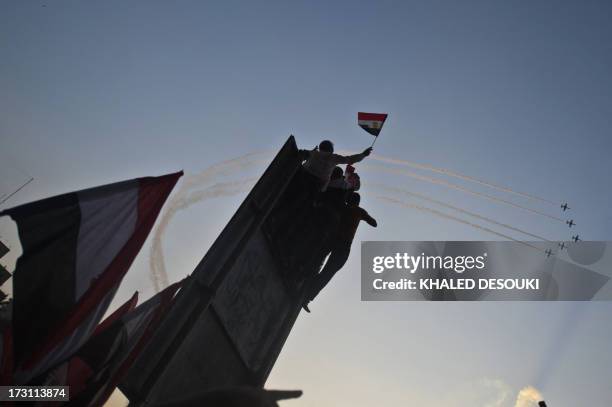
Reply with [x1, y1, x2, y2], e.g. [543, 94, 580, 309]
[119, 136, 322, 405]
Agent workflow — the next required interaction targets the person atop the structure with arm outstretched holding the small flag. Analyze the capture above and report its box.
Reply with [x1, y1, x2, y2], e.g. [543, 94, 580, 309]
[300, 140, 372, 191]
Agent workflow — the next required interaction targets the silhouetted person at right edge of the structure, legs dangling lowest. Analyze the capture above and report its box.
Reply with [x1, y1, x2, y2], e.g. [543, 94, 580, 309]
[303, 192, 377, 312]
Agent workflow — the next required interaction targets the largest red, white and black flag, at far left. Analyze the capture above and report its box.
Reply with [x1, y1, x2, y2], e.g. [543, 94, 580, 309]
[0, 171, 183, 384]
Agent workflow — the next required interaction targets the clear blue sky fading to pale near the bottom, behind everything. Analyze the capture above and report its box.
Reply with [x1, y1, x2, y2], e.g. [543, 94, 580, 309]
[0, 0, 612, 407]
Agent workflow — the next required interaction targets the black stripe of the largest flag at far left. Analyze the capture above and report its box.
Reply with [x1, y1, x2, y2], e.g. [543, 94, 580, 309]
[5, 193, 81, 361]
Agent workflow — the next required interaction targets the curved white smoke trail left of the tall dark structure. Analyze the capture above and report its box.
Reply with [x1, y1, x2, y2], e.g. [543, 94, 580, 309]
[149, 151, 272, 292]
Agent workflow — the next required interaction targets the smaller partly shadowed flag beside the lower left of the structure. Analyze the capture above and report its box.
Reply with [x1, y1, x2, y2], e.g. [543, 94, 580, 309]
[66, 280, 184, 406]
